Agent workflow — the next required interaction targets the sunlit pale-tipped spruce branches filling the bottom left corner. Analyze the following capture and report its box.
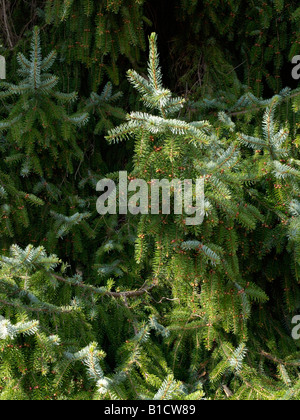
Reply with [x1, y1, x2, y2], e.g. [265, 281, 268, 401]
[0, 246, 204, 400]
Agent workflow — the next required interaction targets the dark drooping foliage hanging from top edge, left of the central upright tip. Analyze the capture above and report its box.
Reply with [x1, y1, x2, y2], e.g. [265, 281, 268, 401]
[45, 0, 149, 90]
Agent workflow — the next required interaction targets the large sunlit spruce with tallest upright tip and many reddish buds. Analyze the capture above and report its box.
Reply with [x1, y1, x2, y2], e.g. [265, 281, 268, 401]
[107, 34, 299, 399]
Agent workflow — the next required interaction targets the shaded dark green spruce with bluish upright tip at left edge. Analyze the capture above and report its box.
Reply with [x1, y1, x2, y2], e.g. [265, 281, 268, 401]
[0, 28, 113, 266]
